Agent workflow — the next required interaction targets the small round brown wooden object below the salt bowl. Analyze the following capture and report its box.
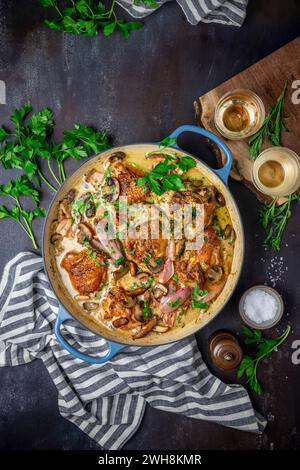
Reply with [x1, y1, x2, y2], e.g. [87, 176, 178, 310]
[209, 331, 243, 370]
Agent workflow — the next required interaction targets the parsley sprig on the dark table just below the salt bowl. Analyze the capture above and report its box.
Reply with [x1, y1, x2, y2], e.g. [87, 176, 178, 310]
[237, 325, 291, 395]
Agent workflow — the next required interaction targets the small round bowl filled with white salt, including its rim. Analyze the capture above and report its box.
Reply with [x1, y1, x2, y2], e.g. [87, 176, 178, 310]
[239, 285, 284, 330]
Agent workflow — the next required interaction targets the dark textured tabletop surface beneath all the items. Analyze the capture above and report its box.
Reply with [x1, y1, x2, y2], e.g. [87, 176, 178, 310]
[0, 0, 300, 449]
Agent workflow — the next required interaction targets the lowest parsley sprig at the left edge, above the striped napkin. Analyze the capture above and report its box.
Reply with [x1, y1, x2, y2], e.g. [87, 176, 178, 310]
[0, 175, 46, 248]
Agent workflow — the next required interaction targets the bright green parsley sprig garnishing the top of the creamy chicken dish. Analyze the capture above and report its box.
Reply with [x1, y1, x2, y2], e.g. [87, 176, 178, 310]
[136, 151, 196, 196]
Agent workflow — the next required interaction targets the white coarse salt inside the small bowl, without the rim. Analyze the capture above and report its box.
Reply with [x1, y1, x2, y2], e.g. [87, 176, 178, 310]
[244, 289, 278, 324]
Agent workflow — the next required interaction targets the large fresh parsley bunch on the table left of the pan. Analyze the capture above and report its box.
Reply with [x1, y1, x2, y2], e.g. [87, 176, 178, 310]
[0, 103, 109, 248]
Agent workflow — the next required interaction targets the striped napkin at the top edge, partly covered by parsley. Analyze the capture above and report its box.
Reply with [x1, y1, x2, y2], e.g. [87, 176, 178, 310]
[117, 0, 248, 26]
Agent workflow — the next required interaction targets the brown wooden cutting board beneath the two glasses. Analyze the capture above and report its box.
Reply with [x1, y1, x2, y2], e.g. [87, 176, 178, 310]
[194, 37, 300, 201]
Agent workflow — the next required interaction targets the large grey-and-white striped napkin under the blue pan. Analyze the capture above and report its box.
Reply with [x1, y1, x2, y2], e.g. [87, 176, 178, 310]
[0, 252, 266, 449]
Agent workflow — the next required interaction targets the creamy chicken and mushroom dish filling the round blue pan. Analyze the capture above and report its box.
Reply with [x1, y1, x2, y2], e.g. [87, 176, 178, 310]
[51, 149, 235, 339]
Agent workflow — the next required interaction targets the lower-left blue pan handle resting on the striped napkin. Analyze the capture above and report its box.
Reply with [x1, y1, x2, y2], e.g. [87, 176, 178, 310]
[54, 304, 126, 364]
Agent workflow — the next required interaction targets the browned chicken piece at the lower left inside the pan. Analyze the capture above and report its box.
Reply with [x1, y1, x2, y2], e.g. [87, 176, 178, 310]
[61, 250, 107, 295]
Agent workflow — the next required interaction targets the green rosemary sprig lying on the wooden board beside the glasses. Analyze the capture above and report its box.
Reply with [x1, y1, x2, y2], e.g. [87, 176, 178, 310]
[248, 80, 288, 159]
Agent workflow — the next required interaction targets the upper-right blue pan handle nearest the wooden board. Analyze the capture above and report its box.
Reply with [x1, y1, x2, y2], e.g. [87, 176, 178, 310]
[169, 125, 233, 185]
